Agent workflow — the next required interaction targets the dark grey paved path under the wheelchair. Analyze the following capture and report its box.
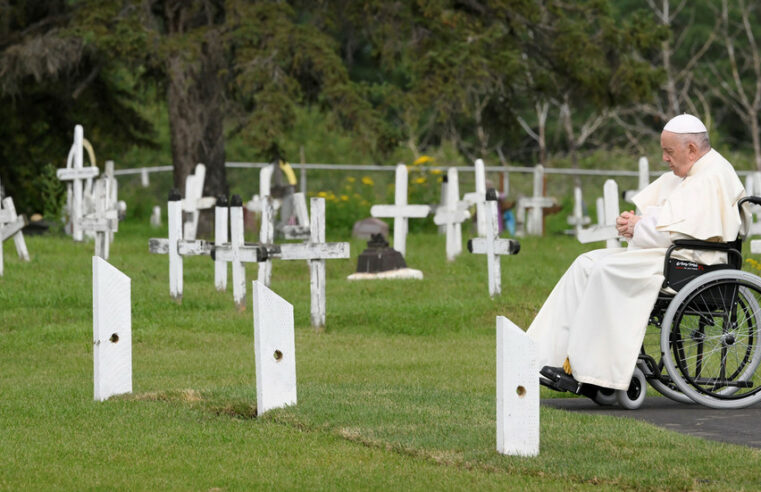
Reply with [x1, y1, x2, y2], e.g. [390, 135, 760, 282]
[542, 397, 761, 448]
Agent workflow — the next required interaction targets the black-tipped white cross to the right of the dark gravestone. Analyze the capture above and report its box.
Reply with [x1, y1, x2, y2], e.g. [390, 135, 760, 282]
[468, 188, 521, 297]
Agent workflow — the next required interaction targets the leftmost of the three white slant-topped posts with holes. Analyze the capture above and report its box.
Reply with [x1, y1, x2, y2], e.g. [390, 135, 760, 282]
[92, 256, 132, 401]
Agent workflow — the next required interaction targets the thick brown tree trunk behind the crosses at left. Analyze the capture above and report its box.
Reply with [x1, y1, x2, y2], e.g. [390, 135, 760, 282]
[167, 33, 229, 236]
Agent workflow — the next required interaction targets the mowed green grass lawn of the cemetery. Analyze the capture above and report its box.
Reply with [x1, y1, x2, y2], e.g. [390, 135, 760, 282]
[0, 223, 761, 490]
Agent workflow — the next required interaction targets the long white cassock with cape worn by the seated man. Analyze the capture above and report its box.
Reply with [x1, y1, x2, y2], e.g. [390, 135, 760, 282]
[527, 149, 745, 389]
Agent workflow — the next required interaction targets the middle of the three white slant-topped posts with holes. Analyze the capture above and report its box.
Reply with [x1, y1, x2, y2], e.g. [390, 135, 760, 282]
[252, 280, 296, 415]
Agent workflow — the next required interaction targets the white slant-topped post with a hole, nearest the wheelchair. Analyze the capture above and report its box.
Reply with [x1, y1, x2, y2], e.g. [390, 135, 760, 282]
[497, 316, 539, 456]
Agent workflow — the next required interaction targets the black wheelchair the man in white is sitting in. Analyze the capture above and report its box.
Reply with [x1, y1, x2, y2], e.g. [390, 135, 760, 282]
[593, 196, 761, 410]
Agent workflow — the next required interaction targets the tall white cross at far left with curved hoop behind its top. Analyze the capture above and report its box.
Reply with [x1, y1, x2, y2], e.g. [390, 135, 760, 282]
[56, 125, 99, 241]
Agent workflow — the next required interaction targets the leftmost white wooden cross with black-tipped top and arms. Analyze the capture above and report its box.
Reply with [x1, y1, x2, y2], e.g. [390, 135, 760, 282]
[148, 189, 213, 302]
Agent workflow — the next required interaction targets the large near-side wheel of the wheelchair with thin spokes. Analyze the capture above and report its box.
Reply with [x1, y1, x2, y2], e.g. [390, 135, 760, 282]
[661, 270, 761, 408]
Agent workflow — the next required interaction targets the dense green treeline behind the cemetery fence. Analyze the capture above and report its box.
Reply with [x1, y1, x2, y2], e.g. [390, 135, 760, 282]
[0, 0, 761, 211]
